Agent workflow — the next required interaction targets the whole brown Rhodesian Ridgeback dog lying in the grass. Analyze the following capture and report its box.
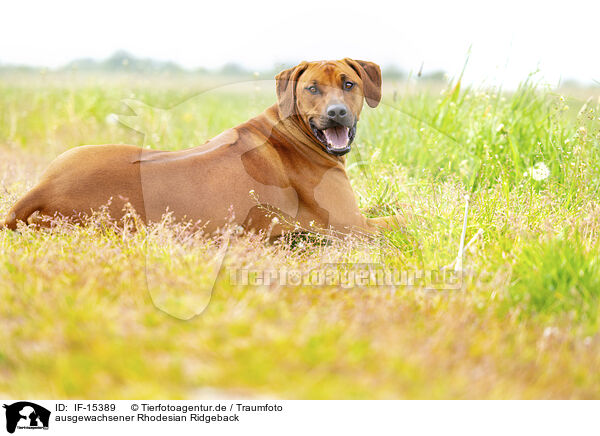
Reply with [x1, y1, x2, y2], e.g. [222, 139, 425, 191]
[4, 59, 398, 236]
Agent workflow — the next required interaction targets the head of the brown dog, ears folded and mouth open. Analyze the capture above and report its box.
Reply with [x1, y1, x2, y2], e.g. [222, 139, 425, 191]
[275, 58, 381, 156]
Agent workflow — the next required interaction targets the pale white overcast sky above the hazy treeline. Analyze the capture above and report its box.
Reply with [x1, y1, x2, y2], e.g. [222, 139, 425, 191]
[0, 0, 600, 86]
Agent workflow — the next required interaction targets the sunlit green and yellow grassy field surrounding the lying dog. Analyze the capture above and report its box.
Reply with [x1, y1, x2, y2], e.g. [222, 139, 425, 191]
[0, 73, 600, 399]
